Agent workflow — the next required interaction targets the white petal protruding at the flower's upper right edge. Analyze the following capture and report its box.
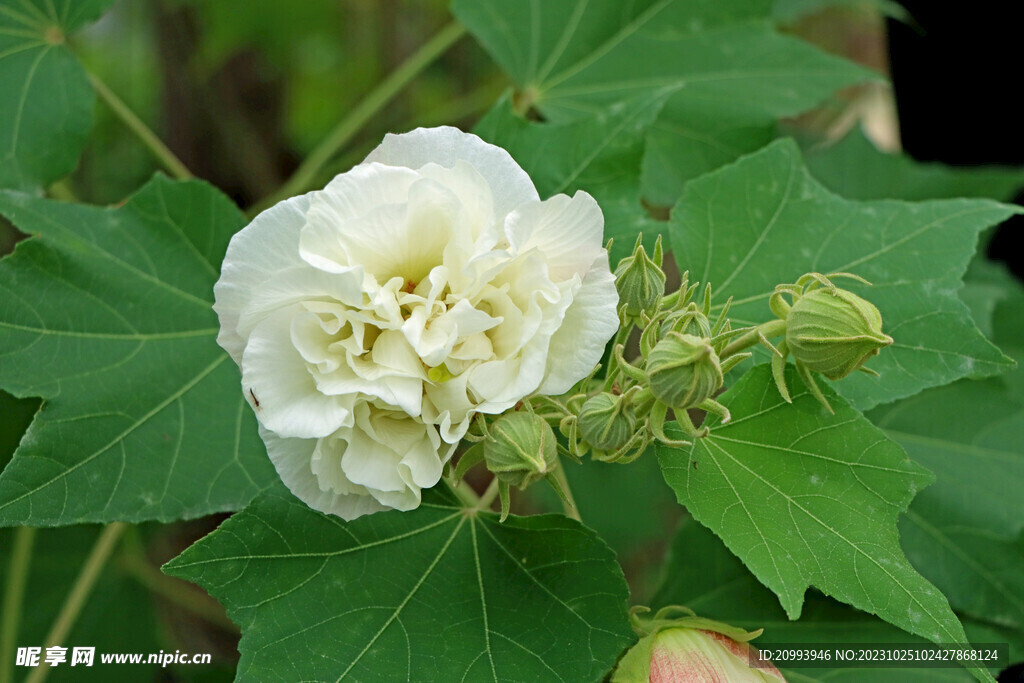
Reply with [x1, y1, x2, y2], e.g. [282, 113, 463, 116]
[505, 191, 604, 282]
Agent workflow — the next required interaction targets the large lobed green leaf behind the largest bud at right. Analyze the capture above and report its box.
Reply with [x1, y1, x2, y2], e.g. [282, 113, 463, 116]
[669, 140, 1021, 410]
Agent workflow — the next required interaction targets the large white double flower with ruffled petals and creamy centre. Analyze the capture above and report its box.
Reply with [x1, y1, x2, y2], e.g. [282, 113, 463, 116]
[214, 128, 617, 519]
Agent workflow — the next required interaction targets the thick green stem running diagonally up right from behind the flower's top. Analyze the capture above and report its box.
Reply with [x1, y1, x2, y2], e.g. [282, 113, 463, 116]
[250, 22, 466, 214]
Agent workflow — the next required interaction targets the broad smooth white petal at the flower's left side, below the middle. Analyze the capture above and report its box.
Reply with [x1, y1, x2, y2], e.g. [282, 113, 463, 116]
[241, 306, 354, 438]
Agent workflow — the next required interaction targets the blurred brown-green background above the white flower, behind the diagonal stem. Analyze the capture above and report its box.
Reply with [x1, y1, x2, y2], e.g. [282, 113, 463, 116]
[71, 0, 507, 207]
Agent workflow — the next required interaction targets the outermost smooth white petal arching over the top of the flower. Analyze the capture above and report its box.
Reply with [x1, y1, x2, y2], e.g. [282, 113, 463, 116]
[366, 126, 540, 222]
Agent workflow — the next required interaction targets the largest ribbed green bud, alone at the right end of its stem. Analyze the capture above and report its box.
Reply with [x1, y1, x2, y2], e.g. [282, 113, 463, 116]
[785, 289, 893, 380]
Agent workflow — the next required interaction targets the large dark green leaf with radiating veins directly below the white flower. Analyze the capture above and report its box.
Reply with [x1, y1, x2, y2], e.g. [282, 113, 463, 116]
[165, 493, 633, 681]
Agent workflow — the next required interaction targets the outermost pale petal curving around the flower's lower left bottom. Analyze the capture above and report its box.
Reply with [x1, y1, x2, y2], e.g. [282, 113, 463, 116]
[259, 426, 387, 519]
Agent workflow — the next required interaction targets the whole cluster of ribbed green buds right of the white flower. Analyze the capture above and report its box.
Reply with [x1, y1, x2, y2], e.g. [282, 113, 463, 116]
[444, 250, 893, 519]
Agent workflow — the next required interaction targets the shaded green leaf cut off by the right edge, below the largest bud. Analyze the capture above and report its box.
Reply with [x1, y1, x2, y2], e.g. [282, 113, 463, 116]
[869, 378, 1024, 628]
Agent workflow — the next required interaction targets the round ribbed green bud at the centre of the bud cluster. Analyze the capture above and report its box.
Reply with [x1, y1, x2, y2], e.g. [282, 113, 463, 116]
[647, 332, 724, 410]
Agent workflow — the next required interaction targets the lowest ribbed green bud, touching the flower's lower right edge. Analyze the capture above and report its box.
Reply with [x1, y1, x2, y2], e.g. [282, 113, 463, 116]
[483, 412, 558, 488]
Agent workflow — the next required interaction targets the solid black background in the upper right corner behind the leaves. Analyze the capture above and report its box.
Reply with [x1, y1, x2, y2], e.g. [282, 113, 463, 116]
[889, 0, 1024, 278]
